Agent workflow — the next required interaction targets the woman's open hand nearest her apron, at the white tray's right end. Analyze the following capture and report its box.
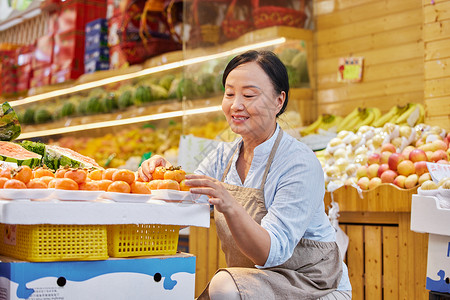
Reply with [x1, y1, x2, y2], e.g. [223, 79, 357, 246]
[186, 174, 237, 214]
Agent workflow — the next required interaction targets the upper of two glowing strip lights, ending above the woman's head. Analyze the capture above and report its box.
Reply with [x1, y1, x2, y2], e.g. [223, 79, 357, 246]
[10, 37, 286, 107]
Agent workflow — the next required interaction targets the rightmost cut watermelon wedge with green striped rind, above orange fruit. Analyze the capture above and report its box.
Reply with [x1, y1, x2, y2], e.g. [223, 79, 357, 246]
[43, 145, 100, 170]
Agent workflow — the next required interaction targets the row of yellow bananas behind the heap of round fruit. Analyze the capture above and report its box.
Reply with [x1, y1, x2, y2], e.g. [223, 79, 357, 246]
[300, 103, 425, 136]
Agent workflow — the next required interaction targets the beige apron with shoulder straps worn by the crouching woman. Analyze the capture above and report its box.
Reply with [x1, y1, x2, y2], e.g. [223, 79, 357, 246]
[198, 129, 342, 300]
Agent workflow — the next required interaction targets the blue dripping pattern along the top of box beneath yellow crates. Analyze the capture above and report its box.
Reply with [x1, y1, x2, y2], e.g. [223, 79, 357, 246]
[0, 257, 195, 299]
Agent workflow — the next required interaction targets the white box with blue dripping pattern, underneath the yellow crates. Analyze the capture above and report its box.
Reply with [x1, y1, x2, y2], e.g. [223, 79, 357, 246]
[0, 253, 195, 300]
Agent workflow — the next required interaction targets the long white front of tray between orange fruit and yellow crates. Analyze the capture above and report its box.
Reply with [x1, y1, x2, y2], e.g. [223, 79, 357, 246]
[0, 200, 210, 227]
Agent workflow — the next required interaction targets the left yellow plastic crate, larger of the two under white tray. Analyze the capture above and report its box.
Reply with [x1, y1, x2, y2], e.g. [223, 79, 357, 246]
[0, 224, 108, 262]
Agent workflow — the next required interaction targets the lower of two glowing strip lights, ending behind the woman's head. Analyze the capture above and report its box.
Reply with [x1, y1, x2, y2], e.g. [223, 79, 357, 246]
[17, 105, 222, 140]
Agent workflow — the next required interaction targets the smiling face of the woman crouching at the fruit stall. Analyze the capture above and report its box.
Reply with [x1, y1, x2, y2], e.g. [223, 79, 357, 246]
[222, 62, 285, 142]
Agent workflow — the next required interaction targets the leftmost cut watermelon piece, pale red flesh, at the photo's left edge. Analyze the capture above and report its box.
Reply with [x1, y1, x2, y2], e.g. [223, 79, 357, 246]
[0, 141, 42, 168]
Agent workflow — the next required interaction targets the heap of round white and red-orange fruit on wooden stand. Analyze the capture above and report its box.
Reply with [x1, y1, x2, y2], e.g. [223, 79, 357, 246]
[316, 123, 450, 190]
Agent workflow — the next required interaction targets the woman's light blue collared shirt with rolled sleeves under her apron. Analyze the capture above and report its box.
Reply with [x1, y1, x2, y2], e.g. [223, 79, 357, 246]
[195, 125, 351, 290]
